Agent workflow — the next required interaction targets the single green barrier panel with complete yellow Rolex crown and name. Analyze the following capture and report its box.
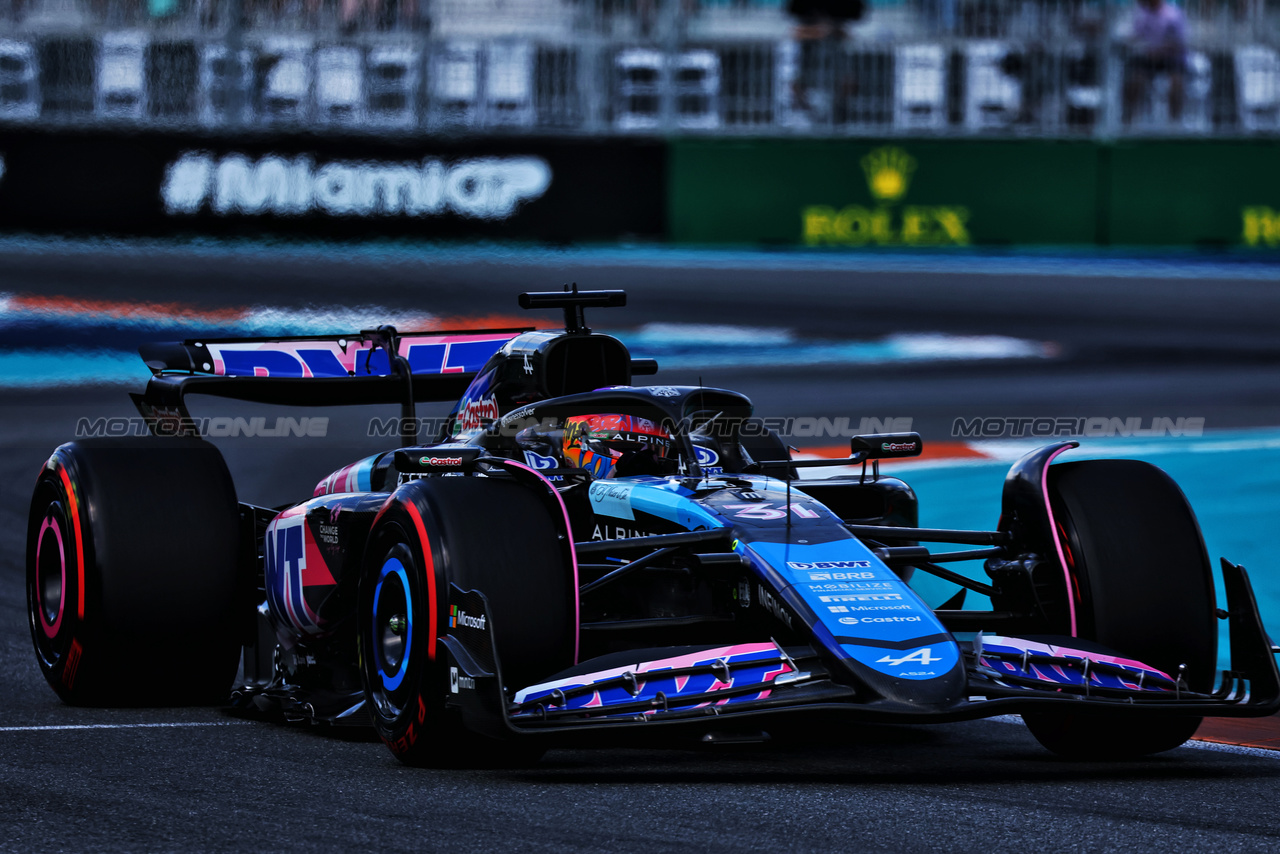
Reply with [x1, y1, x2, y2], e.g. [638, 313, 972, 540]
[668, 140, 1098, 246]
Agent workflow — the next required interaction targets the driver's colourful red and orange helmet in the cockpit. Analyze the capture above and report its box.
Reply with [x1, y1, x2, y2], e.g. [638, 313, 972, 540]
[563, 414, 673, 480]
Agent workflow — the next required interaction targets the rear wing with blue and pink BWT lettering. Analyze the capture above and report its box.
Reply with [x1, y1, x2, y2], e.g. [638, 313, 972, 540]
[131, 326, 531, 444]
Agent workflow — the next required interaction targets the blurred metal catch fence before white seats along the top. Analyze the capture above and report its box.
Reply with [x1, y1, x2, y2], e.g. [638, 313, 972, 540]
[0, 0, 1280, 137]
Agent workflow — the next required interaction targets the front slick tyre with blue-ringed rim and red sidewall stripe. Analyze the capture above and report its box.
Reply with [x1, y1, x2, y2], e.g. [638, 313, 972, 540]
[360, 478, 577, 767]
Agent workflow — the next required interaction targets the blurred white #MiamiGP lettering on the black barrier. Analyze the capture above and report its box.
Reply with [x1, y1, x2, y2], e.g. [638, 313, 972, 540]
[160, 151, 552, 219]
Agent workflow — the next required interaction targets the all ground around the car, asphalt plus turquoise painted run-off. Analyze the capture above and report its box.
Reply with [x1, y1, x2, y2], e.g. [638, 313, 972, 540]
[0, 238, 1280, 851]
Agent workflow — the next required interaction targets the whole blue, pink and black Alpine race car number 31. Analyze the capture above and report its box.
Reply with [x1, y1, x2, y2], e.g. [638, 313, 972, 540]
[27, 287, 1280, 766]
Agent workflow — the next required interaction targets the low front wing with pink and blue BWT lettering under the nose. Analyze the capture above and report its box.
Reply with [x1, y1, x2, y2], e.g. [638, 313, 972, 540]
[442, 561, 1280, 744]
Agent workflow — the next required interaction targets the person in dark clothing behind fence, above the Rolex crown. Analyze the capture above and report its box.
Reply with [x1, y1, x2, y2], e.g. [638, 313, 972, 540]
[787, 0, 867, 118]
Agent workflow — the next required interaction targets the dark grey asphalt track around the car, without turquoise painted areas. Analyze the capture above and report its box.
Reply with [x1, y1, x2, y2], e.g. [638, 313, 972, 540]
[0, 245, 1280, 851]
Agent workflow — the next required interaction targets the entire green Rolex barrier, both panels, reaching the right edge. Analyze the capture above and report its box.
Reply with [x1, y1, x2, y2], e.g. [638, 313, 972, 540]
[668, 140, 1280, 248]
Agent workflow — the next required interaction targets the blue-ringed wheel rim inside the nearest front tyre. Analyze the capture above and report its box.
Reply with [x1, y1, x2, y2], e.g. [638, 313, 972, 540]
[369, 549, 413, 717]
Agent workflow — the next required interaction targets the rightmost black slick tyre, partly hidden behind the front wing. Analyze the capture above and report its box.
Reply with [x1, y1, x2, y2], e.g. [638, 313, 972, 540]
[1023, 460, 1217, 759]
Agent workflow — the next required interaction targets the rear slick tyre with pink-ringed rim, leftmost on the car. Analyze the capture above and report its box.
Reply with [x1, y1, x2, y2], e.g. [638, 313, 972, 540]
[27, 438, 246, 705]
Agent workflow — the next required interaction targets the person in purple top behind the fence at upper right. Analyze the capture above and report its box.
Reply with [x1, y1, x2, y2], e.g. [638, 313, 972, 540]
[1123, 0, 1187, 124]
